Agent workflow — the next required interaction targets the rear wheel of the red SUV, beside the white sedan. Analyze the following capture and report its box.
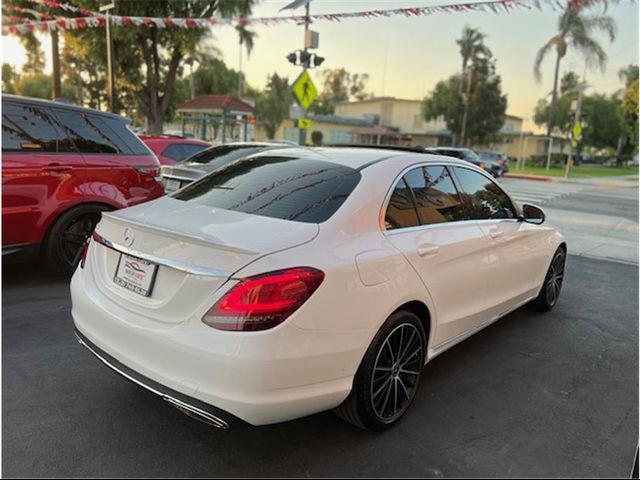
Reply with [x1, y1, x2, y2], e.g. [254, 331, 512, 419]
[44, 204, 110, 276]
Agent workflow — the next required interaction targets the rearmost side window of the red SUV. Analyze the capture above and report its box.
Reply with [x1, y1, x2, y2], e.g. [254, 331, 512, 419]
[55, 110, 122, 153]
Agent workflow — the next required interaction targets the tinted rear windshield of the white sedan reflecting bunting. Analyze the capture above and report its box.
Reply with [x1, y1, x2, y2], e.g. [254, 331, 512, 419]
[174, 156, 360, 223]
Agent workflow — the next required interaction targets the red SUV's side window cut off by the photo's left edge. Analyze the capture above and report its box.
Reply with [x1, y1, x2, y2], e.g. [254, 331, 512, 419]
[2, 103, 76, 153]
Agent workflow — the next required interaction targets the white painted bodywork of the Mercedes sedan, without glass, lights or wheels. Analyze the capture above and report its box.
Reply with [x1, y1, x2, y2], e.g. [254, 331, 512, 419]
[71, 149, 563, 425]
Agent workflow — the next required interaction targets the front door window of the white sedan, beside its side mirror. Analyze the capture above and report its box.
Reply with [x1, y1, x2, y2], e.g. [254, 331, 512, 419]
[454, 167, 516, 220]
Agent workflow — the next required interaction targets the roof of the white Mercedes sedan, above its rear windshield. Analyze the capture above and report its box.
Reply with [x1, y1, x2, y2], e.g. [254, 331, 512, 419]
[245, 147, 469, 170]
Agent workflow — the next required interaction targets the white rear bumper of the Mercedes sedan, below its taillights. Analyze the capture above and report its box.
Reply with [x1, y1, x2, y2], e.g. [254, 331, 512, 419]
[71, 269, 366, 426]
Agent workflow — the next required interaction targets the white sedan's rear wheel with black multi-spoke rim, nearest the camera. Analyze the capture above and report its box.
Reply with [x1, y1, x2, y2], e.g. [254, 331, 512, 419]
[335, 311, 427, 431]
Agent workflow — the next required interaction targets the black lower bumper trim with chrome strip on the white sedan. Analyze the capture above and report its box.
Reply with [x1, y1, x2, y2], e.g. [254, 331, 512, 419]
[75, 328, 247, 429]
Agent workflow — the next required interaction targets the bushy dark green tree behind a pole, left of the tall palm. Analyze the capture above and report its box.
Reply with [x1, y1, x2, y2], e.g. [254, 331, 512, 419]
[422, 27, 507, 145]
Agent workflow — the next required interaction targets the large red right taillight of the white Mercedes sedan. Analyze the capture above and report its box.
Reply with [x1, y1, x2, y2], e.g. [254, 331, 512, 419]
[202, 267, 324, 332]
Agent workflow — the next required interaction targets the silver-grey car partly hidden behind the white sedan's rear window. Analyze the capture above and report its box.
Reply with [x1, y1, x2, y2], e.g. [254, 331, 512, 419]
[160, 142, 292, 193]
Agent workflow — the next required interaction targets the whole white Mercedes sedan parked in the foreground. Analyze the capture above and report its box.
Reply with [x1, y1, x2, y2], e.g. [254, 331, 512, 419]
[71, 148, 567, 430]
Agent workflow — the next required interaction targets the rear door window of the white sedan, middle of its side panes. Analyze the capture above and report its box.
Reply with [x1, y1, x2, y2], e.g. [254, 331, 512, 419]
[405, 166, 465, 225]
